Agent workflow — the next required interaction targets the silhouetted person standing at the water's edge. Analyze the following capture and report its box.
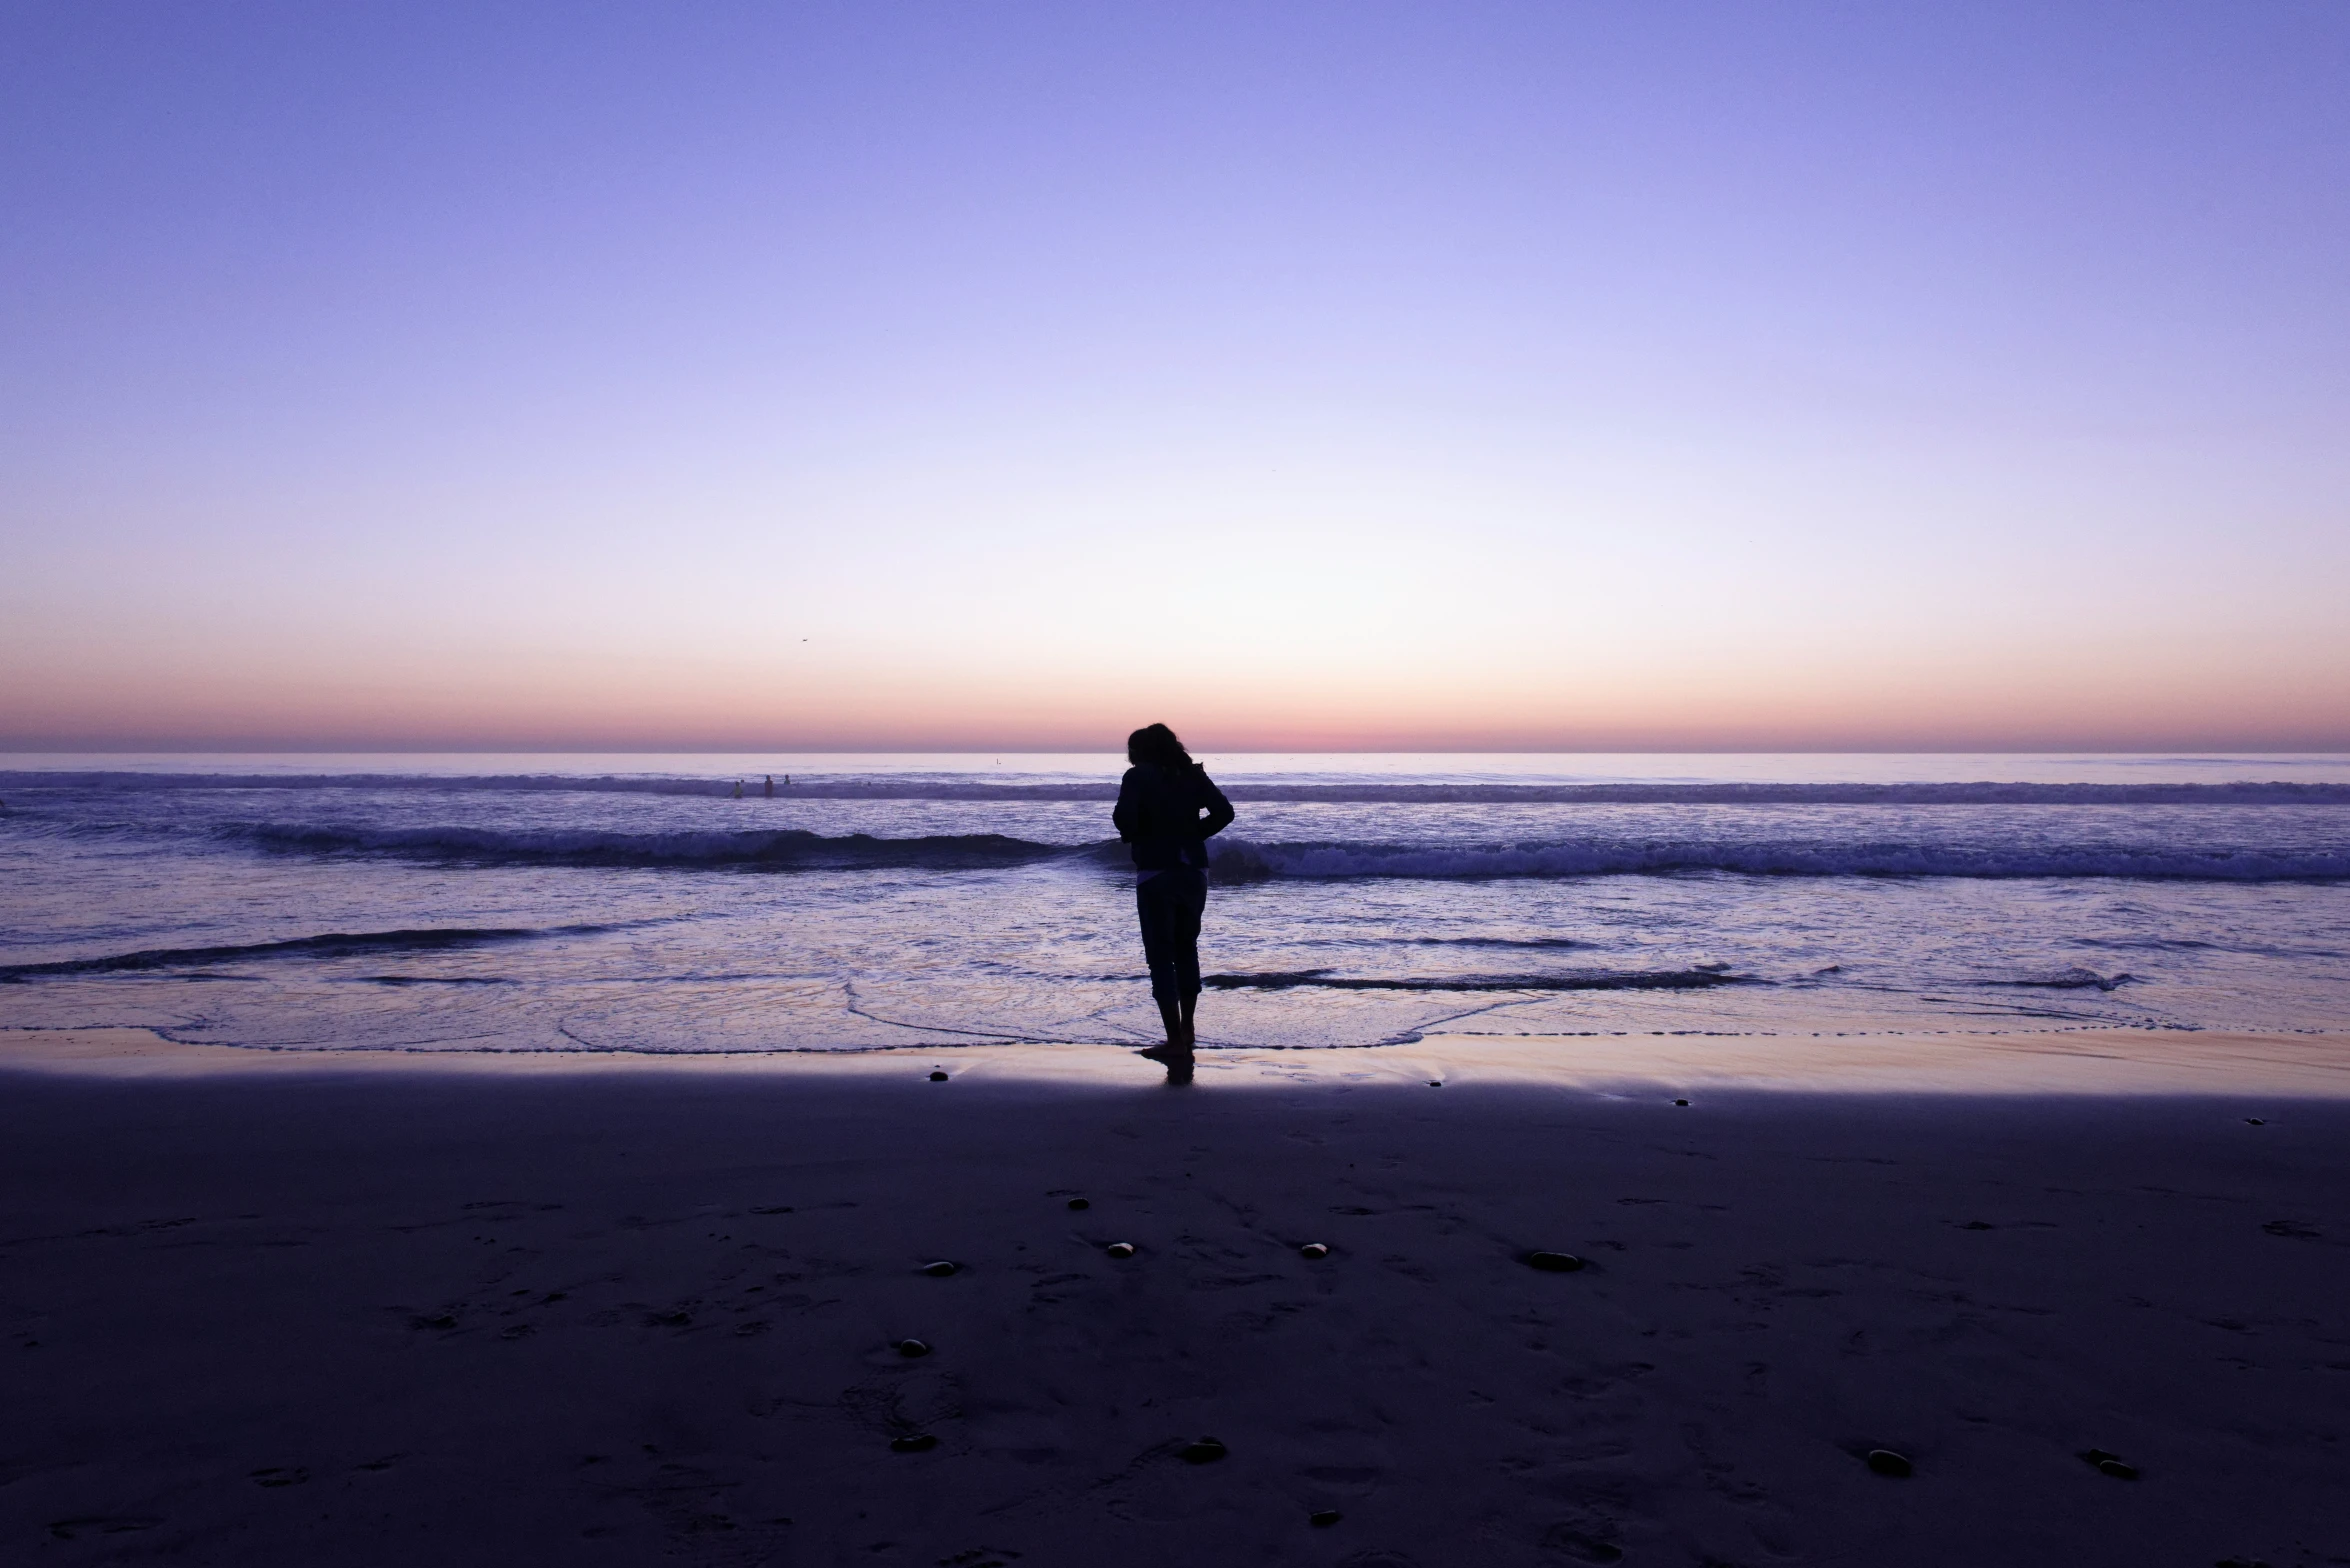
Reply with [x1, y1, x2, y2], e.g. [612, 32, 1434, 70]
[1109, 724, 1231, 1056]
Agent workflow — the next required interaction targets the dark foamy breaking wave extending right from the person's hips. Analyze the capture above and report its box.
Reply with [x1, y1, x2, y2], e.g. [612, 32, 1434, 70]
[1210, 837, 2350, 882]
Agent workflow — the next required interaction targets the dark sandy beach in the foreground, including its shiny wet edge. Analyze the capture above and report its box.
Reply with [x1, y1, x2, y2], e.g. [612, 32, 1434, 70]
[0, 1032, 2350, 1568]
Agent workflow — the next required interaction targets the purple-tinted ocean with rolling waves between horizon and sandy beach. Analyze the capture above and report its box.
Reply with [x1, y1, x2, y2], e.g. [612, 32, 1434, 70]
[0, 755, 2350, 1051]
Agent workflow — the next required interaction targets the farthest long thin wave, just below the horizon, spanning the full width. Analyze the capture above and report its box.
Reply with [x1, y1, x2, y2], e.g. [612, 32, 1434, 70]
[13, 769, 2350, 806]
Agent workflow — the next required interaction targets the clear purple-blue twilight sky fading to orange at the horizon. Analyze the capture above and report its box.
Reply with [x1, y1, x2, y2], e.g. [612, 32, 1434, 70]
[0, 0, 2350, 752]
